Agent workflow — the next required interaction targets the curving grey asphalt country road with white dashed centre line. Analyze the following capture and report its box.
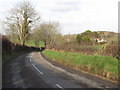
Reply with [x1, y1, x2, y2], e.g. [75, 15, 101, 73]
[2, 52, 117, 90]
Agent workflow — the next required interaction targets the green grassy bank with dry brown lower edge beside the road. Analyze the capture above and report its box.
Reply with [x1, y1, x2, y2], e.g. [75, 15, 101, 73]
[43, 50, 118, 81]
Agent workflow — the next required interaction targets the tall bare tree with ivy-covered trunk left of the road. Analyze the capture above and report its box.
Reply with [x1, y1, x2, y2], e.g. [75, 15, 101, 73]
[5, 1, 40, 45]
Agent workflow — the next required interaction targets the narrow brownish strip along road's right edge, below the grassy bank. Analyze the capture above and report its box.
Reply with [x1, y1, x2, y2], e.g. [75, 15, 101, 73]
[40, 52, 119, 89]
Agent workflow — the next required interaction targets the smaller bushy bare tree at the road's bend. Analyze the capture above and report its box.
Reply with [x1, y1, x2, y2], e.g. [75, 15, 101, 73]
[33, 22, 60, 46]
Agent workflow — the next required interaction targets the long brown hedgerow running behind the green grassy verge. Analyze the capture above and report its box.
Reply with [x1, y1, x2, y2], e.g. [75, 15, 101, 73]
[49, 42, 120, 60]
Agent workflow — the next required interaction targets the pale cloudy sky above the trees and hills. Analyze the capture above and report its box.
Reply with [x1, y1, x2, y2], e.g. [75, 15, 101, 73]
[0, 0, 120, 34]
